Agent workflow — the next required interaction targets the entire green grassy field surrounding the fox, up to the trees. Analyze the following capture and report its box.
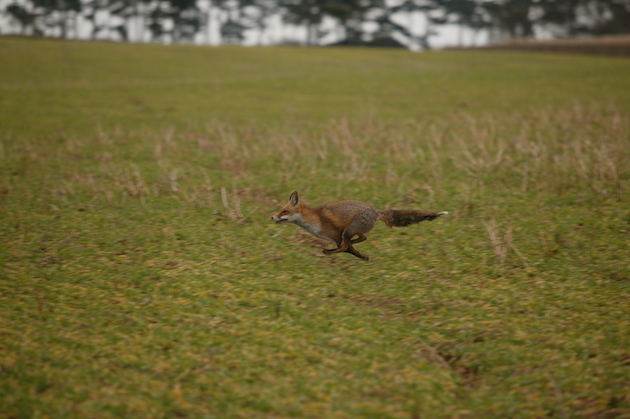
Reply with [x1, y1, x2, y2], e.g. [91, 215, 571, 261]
[0, 38, 630, 418]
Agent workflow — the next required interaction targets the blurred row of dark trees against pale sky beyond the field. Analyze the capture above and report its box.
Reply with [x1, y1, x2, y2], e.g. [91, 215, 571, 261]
[0, 0, 630, 49]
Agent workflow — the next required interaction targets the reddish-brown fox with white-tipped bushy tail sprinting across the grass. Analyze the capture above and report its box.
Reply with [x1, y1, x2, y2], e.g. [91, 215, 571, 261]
[271, 192, 448, 260]
